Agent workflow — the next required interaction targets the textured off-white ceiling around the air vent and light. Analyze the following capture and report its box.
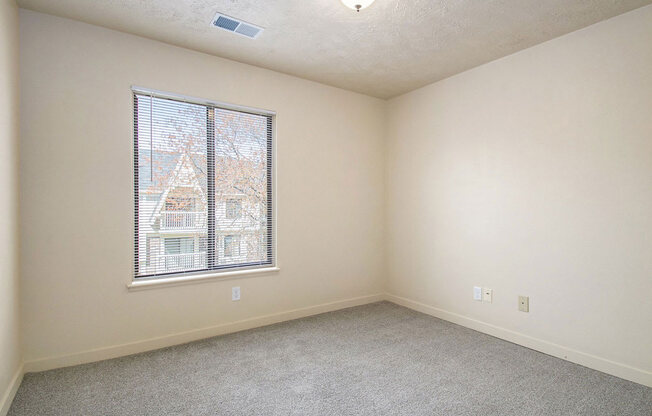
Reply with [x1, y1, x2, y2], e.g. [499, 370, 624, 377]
[18, 0, 652, 98]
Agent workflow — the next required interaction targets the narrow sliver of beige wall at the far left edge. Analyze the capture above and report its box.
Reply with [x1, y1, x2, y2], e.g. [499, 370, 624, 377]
[0, 0, 21, 413]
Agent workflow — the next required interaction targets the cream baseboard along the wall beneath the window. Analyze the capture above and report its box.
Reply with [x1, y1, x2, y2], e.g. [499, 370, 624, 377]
[22, 294, 385, 374]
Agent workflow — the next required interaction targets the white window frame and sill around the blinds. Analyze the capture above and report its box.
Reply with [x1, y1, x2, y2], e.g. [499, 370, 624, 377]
[127, 86, 280, 291]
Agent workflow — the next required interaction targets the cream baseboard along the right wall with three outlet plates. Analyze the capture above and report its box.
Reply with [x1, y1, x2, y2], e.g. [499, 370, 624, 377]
[385, 294, 652, 387]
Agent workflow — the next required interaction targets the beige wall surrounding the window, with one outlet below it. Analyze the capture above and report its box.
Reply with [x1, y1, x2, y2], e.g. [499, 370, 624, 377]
[20, 10, 385, 361]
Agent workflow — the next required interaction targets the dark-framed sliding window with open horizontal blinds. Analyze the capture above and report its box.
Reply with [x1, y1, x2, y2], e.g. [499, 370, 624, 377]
[133, 89, 274, 278]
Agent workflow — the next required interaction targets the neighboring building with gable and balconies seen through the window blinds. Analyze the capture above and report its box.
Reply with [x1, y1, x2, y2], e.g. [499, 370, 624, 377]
[138, 152, 266, 275]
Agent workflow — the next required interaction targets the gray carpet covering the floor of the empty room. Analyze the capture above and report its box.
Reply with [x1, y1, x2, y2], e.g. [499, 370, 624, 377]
[9, 302, 652, 416]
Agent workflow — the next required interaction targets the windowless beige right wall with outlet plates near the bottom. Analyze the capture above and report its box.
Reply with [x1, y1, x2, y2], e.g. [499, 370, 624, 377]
[386, 6, 652, 376]
